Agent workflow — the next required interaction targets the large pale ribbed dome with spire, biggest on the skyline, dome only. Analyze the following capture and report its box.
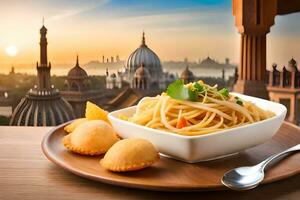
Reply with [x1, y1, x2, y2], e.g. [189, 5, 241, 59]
[126, 33, 162, 77]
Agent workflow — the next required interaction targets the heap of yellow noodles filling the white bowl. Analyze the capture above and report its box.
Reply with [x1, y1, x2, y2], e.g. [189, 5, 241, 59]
[122, 81, 274, 136]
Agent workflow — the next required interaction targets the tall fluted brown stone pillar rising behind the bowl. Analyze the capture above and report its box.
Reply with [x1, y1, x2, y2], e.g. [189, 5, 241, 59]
[232, 0, 277, 98]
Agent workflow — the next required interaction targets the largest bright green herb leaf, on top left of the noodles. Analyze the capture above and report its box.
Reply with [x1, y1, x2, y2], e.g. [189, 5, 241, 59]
[167, 80, 198, 101]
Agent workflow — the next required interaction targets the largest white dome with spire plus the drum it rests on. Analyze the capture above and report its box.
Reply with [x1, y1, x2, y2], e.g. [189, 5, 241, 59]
[124, 32, 163, 89]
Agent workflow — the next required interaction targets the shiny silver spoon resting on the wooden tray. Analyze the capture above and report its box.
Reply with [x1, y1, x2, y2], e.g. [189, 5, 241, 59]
[221, 144, 300, 190]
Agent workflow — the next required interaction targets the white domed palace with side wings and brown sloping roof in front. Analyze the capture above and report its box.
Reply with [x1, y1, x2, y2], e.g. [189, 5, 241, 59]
[106, 33, 175, 110]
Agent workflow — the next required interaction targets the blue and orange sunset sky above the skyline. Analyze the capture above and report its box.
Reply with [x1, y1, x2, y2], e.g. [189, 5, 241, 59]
[0, 0, 300, 68]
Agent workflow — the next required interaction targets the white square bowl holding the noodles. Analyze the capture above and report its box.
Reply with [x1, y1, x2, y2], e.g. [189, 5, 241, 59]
[108, 93, 286, 163]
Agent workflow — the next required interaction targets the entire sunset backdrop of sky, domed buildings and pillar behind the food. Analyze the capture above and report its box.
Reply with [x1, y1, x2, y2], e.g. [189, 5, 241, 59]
[0, 0, 300, 126]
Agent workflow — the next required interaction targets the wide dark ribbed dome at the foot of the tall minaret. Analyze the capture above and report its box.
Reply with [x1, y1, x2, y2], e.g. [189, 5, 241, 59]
[10, 90, 74, 126]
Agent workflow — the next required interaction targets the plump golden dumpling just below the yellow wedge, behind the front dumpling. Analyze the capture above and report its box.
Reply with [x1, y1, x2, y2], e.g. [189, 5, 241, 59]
[62, 120, 119, 155]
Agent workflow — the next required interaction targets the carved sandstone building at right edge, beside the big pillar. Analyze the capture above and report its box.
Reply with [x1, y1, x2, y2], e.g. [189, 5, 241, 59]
[267, 58, 300, 125]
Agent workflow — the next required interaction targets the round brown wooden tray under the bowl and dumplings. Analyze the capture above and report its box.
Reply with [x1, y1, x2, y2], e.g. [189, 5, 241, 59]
[42, 122, 300, 191]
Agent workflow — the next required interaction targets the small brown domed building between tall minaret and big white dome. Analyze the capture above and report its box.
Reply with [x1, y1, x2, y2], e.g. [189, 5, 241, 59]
[61, 55, 103, 118]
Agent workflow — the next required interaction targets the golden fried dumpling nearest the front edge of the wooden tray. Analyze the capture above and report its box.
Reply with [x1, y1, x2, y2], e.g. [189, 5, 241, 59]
[100, 138, 159, 172]
